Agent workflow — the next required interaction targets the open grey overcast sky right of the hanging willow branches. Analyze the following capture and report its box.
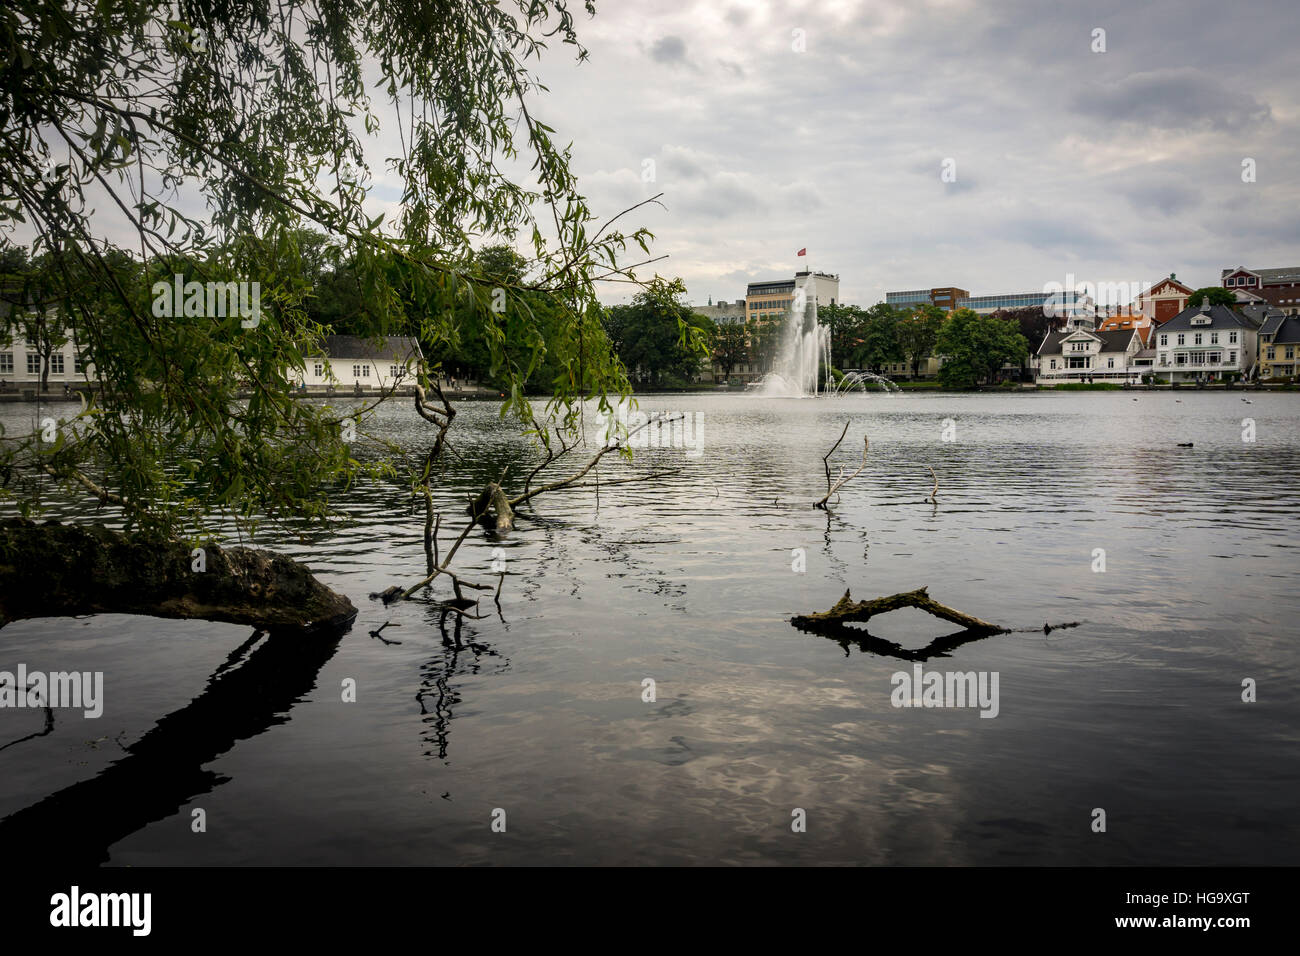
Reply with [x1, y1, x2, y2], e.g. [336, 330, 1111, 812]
[520, 0, 1300, 304]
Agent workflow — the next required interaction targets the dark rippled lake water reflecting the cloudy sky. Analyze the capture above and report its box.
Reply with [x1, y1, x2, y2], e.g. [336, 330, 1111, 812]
[0, 389, 1300, 866]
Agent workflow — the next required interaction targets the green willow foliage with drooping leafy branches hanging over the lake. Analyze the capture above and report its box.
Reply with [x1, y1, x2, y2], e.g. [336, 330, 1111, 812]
[0, 0, 649, 546]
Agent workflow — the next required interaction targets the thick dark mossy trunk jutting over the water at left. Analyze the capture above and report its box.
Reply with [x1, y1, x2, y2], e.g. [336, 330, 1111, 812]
[0, 518, 356, 633]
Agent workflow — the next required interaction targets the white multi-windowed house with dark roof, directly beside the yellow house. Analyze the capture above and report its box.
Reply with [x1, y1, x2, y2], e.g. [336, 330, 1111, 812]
[1152, 303, 1262, 382]
